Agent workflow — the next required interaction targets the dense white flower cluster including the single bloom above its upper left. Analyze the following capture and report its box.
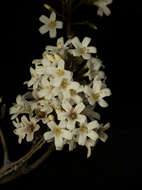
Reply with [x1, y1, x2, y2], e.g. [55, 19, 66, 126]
[10, 8, 111, 157]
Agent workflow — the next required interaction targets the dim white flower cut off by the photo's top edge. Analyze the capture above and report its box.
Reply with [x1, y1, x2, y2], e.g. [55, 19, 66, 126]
[94, 0, 112, 16]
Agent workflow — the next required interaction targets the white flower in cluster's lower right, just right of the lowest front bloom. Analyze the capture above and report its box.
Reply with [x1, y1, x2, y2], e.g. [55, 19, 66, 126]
[78, 121, 99, 146]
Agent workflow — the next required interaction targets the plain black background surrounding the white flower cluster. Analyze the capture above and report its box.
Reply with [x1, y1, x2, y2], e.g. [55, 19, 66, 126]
[0, 0, 142, 186]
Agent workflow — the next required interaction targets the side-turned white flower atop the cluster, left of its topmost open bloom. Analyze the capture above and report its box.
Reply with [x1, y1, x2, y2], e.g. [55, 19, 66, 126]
[46, 37, 71, 56]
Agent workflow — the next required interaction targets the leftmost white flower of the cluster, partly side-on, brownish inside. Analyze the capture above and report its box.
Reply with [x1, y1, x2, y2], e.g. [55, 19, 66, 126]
[10, 95, 31, 120]
